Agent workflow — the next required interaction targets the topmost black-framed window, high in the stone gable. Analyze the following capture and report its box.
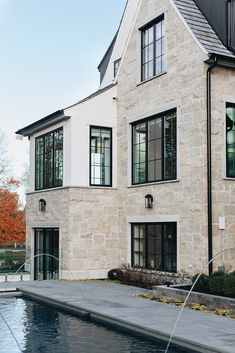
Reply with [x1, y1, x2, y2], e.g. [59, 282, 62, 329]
[141, 17, 165, 81]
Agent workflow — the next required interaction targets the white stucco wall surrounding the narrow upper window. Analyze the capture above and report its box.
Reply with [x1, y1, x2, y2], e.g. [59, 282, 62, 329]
[64, 86, 117, 187]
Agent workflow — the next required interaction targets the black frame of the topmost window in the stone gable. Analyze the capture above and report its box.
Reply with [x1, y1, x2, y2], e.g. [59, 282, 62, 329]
[139, 14, 166, 82]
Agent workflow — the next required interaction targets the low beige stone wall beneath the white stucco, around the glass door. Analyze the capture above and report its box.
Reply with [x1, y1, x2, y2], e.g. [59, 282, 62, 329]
[27, 188, 120, 279]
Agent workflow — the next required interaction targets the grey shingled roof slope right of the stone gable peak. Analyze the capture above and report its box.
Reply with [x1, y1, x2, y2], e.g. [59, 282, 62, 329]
[173, 0, 235, 59]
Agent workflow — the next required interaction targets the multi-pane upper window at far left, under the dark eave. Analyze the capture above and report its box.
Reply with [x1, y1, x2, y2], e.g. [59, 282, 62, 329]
[35, 128, 63, 190]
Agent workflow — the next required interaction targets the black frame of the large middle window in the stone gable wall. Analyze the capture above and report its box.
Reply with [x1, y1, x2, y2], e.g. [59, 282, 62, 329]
[131, 108, 178, 185]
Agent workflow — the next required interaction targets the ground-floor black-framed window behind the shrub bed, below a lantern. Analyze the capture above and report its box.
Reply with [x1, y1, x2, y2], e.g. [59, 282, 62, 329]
[131, 222, 177, 272]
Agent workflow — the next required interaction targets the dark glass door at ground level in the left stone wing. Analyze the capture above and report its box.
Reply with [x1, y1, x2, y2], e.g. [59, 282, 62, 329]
[34, 228, 59, 280]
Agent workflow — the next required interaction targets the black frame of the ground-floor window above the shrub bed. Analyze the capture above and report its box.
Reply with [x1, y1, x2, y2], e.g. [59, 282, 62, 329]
[131, 222, 177, 273]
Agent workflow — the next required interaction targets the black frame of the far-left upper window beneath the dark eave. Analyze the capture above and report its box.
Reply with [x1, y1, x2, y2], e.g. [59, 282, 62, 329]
[34, 127, 64, 191]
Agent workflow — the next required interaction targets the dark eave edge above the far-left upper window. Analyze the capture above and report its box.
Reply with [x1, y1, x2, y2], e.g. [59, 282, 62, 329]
[15, 110, 70, 136]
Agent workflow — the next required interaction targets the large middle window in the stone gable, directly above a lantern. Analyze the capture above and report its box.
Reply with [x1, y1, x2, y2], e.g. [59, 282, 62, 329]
[132, 110, 177, 184]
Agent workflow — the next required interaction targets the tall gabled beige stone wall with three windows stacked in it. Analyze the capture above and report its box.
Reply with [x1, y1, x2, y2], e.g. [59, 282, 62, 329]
[117, 0, 235, 274]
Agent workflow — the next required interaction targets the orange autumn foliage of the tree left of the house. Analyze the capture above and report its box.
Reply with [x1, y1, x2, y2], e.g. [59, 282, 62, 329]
[0, 179, 25, 245]
